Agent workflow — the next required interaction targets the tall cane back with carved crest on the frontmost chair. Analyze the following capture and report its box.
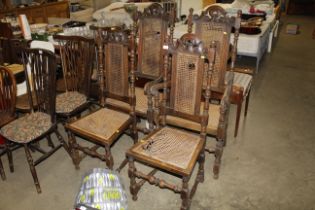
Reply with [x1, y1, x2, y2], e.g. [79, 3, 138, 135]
[163, 34, 215, 123]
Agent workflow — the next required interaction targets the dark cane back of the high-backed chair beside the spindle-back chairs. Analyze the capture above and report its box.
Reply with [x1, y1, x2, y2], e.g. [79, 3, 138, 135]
[91, 26, 134, 105]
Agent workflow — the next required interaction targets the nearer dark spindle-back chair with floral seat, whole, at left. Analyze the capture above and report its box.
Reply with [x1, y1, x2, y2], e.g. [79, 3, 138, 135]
[1, 49, 69, 193]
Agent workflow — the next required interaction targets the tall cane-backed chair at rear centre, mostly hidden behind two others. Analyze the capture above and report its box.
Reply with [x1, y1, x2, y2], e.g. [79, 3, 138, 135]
[103, 3, 169, 128]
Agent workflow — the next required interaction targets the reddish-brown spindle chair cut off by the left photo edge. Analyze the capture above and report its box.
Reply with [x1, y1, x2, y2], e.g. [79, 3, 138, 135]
[0, 66, 16, 180]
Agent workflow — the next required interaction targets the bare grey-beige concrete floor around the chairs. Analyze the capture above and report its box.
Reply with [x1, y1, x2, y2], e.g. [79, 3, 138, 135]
[0, 16, 315, 210]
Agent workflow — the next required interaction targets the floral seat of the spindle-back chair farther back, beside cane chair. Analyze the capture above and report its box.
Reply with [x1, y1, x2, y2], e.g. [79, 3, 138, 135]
[56, 91, 87, 113]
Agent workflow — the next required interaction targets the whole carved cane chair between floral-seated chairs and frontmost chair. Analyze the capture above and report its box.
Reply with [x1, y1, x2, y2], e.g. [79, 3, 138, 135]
[66, 26, 138, 169]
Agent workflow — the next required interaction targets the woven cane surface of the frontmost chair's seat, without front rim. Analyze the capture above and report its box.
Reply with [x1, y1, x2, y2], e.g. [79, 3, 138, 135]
[133, 127, 200, 170]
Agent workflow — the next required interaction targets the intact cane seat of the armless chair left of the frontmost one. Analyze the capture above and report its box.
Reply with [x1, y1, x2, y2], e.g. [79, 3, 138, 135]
[68, 108, 130, 142]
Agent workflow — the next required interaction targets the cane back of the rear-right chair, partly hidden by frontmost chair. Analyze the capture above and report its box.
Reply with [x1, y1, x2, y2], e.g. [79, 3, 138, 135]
[193, 5, 240, 91]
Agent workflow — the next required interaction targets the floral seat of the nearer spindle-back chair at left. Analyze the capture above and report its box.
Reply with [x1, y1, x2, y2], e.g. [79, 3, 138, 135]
[0, 112, 52, 143]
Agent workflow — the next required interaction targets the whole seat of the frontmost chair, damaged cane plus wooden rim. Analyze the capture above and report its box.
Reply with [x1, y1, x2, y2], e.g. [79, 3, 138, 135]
[128, 127, 203, 176]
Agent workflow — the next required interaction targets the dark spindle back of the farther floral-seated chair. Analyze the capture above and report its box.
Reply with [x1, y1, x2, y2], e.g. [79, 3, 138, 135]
[54, 35, 95, 95]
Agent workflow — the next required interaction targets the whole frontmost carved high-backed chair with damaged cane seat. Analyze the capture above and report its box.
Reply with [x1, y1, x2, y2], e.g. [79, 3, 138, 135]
[127, 34, 214, 210]
